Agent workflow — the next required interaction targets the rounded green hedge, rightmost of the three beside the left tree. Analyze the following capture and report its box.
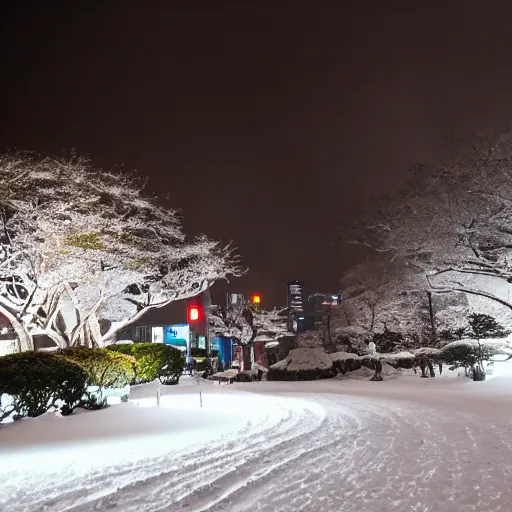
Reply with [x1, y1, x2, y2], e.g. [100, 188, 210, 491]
[107, 343, 185, 384]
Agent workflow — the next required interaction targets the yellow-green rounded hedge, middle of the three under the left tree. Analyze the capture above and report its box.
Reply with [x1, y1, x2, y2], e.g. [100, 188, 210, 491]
[58, 347, 135, 388]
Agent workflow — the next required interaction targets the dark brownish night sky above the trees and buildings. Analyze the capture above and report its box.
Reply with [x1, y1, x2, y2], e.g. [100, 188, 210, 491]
[0, 0, 512, 305]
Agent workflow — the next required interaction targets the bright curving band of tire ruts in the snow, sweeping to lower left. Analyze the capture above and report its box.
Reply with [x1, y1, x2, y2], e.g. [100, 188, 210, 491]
[0, 396, 323, 512]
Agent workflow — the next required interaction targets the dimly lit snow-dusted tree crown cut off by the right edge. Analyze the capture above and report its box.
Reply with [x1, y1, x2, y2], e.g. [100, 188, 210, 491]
[344, 133, 512, 330]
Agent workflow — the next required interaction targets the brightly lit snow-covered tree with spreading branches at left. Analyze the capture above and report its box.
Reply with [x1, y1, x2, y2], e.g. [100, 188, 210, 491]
[0, 153, 241, 350]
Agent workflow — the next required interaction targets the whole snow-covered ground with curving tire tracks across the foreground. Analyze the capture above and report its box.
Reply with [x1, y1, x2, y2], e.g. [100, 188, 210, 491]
[0, 376, 512, 512]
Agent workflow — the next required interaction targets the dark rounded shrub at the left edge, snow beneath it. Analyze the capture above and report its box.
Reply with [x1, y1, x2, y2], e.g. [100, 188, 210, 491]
[0, 352, 87, 421]
